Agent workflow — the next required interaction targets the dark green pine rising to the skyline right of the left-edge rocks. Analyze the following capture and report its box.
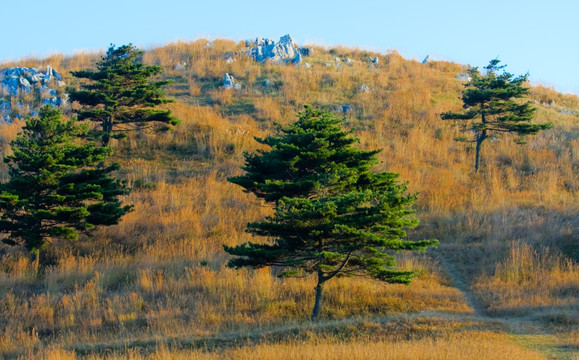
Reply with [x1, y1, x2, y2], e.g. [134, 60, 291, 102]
[69, 44, 179, 145]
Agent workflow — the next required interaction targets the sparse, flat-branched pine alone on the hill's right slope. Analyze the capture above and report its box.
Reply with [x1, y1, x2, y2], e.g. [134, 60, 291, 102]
[441, 59, 551, 173]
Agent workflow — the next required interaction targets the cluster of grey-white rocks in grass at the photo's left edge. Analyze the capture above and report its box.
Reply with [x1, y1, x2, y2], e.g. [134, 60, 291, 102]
[0, 65, 68, 123]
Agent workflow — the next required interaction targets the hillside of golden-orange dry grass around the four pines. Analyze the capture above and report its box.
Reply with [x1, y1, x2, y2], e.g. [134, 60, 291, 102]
[0, 40, 579, 359]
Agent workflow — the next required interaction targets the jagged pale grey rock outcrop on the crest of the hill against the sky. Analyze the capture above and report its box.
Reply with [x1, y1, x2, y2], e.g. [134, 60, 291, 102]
[246, 34, 311, 64]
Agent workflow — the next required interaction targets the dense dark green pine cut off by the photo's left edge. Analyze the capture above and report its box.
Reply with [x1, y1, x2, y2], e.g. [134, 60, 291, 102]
[0, 107, 131, 261]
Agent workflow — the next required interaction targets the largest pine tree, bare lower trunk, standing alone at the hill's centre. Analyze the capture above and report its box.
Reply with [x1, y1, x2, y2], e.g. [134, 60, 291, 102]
[225, 107, 438, 321]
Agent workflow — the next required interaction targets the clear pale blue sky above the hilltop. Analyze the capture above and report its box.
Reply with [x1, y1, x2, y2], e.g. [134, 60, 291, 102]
[0, 0, 579, 94]
